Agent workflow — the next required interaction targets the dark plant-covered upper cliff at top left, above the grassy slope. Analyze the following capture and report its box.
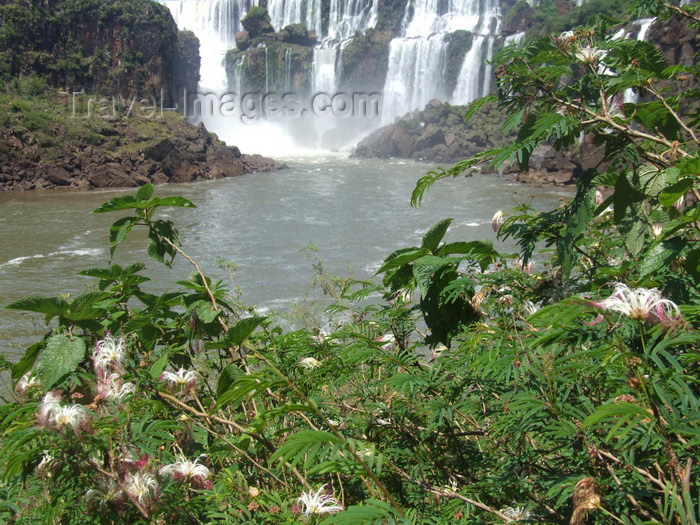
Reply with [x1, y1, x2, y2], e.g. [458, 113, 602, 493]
[0, 0, 177, 93]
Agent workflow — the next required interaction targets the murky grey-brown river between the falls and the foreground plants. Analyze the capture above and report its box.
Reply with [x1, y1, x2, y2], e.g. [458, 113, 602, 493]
[0, 154, 571, 360]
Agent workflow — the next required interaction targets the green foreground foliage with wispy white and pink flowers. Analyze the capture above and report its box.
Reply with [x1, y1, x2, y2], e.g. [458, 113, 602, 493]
[0, 2, 700, 524]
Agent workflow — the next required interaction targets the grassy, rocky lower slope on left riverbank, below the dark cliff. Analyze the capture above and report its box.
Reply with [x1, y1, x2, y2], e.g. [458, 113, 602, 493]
[0, 91, 284, 190]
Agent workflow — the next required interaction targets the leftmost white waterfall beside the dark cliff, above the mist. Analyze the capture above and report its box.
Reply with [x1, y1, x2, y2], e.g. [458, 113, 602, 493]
[159, 0, 252, 91]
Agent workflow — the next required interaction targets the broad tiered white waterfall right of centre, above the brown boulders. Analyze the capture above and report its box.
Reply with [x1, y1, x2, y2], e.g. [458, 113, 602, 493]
[382, 0, 499, 123]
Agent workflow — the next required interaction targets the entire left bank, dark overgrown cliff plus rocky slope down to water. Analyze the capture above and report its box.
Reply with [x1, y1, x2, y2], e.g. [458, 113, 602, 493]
[0, 0, 283, 190]
